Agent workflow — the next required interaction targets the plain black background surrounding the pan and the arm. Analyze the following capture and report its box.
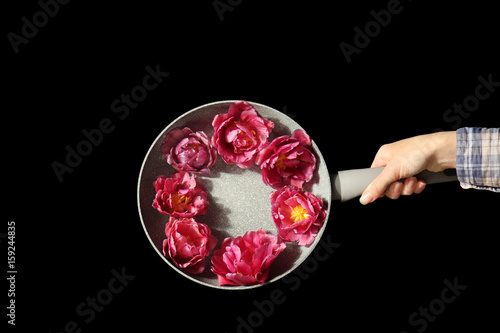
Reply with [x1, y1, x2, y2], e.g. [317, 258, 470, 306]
[4, 0, 500, 333]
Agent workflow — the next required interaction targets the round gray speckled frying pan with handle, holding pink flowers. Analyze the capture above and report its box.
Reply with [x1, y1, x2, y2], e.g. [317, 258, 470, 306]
[137, 100, 456, 290]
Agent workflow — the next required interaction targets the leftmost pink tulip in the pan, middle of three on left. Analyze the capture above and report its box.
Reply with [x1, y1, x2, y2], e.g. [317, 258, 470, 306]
[153, 171, 209, 218]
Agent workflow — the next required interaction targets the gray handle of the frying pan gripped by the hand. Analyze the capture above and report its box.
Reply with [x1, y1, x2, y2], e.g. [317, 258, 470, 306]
[332, 167, 458, 202]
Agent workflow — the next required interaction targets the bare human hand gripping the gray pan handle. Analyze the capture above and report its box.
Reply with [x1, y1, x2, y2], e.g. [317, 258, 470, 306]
[359, 131, 456, 205]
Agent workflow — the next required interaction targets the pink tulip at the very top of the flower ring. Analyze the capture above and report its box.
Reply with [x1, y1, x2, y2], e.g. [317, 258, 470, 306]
[212, 101, 274, 169]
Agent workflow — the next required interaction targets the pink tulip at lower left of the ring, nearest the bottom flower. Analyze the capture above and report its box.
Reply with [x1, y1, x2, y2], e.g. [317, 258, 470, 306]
[163, 217, 217, 274]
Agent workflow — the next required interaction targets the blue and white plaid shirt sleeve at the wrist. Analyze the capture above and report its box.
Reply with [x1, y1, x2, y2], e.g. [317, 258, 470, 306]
[456, 127, 500, 192]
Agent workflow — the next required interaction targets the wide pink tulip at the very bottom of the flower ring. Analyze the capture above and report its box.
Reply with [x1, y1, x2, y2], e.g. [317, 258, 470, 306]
[212, 229, 286, 286]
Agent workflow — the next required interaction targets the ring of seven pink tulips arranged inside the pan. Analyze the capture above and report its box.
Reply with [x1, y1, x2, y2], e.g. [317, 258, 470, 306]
[152, 101, 326, 286]
